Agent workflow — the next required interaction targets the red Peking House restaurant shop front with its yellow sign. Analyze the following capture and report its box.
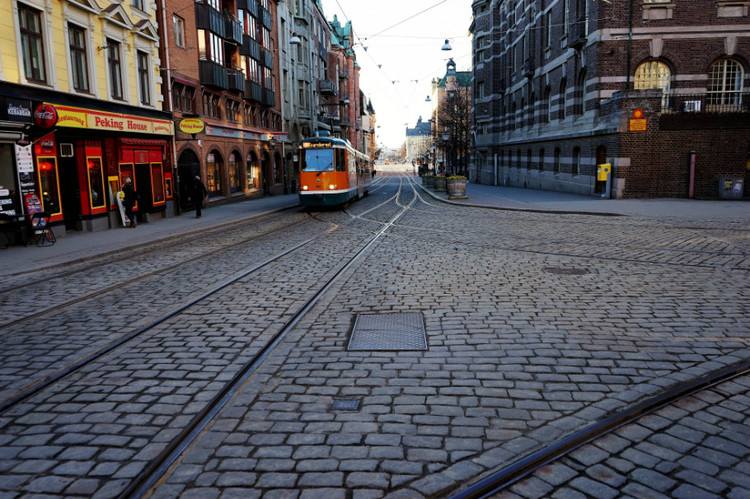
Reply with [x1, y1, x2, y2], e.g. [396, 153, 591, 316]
[28, 102, 174, 231]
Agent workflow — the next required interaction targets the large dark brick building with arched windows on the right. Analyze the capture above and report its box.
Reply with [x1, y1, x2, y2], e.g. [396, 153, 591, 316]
[470, 0, 750, 198]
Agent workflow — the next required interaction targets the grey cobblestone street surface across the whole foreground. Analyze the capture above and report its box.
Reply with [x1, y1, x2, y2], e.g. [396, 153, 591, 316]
[0, 177, 750, 499]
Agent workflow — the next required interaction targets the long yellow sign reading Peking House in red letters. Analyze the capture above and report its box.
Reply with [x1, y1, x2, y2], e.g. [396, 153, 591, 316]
[54, 105, 174, 135]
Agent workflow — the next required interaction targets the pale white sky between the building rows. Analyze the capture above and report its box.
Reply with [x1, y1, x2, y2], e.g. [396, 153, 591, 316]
[321, 0, 472, 149]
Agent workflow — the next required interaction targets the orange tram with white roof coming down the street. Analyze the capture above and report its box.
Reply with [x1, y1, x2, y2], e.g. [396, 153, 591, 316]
[299, 135, 375, 207]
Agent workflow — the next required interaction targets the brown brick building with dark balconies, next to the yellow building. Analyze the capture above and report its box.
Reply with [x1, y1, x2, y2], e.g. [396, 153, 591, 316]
[159, 0, 286, 210]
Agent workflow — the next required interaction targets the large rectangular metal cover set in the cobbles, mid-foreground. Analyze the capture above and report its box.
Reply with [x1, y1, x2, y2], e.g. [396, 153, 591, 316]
[347, 313, 427, 351]
